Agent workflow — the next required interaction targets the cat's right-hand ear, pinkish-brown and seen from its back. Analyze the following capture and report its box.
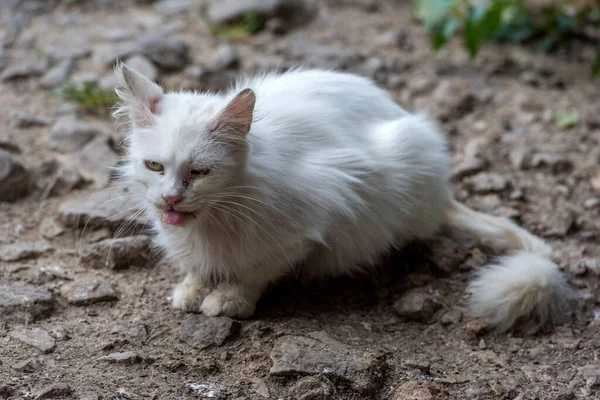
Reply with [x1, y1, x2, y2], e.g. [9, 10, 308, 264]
[211, 89, 256, 137]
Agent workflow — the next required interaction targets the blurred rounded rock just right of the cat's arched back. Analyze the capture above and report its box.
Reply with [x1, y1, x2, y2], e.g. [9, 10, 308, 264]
[432, 79, 477, 120]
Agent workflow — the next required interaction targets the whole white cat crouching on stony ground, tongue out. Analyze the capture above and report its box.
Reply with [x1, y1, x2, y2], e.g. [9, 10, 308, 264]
[116, 65, 570, 329]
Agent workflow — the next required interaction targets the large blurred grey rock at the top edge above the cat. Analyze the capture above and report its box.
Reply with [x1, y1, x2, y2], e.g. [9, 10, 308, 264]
[206, 0, 316, 28]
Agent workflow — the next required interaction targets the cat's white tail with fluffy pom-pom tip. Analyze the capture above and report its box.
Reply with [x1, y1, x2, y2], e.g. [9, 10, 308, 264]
[447, 200, 572, 331]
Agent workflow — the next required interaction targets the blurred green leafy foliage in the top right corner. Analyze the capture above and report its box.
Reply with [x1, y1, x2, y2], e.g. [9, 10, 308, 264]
[415, 0, 600, 76]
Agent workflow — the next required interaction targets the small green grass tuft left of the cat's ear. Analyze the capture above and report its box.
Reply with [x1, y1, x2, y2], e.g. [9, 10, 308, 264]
[55, 81, 118, 115]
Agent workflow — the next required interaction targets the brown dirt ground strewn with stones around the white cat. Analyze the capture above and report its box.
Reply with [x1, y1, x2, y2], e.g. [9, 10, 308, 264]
[0, 0, 600, 400]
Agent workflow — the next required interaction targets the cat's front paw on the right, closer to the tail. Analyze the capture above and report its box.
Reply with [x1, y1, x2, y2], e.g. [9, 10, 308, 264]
[200, 285, 256, 318]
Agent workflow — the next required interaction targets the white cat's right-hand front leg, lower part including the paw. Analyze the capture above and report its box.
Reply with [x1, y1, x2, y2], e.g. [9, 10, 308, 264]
[200, 282, 265, 318]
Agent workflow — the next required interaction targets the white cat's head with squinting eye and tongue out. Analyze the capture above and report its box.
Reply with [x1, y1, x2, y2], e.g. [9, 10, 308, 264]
[115, 64, 255, 225]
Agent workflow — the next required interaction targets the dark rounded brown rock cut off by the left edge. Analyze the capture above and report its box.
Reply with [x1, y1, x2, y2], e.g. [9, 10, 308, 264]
[0, 149, 33, 203]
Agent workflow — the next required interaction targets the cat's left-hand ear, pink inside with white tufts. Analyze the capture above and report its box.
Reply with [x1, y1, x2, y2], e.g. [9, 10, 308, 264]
[115, 63, 164, 128]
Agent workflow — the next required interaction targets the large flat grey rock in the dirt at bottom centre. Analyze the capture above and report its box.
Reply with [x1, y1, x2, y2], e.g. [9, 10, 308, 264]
[269, 332, 384, 394]
